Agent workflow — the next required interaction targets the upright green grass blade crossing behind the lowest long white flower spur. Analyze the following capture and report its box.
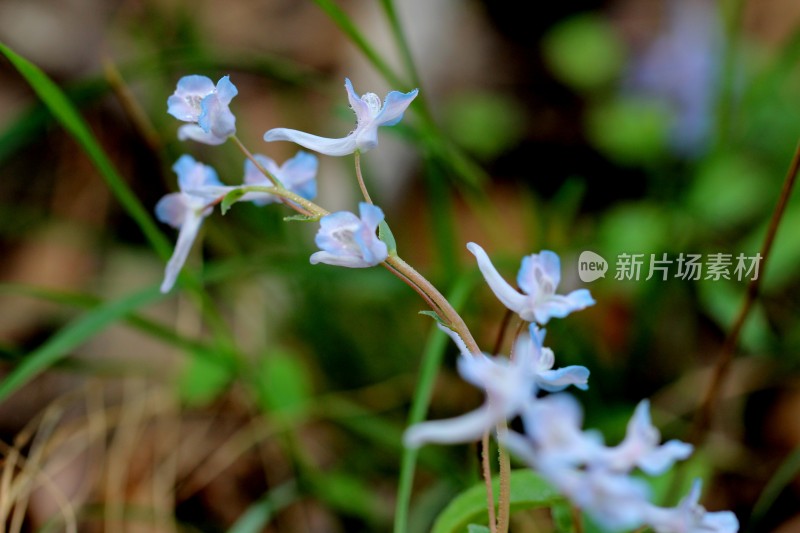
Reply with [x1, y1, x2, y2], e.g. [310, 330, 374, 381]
[393, 275, 475, 533]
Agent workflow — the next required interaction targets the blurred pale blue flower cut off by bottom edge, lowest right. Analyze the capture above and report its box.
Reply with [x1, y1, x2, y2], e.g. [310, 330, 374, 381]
[646, 479, 739, 533]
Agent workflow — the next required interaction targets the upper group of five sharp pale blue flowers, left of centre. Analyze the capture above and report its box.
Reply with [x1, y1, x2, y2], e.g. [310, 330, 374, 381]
[156, 75, 418, 292]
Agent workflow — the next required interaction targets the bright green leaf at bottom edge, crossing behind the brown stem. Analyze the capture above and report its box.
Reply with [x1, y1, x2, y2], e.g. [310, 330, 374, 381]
[432, 469, 567, 533]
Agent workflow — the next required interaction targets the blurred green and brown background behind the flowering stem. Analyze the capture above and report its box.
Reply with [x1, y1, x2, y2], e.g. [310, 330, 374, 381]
[0, 0, 800, 533]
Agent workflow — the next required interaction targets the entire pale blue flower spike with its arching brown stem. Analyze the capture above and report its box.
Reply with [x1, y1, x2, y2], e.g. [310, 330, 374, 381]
[156, 75, 738, 533]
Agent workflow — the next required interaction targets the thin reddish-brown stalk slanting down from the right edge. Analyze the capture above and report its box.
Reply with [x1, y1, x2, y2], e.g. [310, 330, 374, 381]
[690, 142, 800, 442]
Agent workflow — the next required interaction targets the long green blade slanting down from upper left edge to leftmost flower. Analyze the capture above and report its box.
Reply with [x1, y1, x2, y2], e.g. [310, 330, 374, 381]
[0, 43, 172, 259]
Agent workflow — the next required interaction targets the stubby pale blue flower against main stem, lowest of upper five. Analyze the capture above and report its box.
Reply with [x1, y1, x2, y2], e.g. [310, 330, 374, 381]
[310, 202, 389, 268]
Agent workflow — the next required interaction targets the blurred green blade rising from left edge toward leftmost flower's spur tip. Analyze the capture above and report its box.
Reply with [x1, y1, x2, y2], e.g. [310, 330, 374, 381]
[0, 288, 164, 401]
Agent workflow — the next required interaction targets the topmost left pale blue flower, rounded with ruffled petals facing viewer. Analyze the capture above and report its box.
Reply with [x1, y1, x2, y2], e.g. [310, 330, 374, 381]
[167, 75, 234, 145]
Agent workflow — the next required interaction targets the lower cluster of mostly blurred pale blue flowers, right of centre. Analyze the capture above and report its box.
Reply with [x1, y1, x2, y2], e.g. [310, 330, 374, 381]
[405, 243, 739, 533]
